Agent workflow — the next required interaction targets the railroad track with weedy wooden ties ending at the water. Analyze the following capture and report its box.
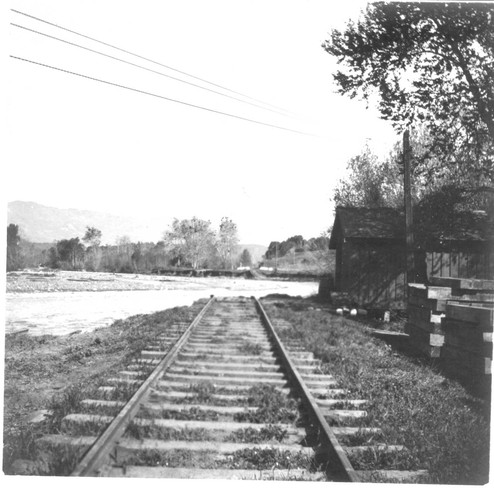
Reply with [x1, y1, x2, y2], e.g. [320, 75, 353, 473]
[38, 298, 424, 482]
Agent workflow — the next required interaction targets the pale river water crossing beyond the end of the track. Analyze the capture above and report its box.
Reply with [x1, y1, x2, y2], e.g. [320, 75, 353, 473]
[5, 278, 318, 335]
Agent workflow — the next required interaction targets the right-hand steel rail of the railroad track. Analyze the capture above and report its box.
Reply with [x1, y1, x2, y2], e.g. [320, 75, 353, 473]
[252, 297, 359, 482]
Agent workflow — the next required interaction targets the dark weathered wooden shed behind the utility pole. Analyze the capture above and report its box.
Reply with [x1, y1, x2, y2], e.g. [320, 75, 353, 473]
[329, 207, 494, 309]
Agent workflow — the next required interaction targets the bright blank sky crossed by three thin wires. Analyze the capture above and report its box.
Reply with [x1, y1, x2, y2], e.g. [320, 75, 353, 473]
[2, 0, 398, 245]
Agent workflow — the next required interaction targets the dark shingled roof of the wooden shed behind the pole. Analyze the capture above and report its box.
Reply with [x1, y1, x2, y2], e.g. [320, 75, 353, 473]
[329, 207, 494, 248]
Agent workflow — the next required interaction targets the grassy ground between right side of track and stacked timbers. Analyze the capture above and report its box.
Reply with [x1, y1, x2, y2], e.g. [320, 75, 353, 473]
[265, 299, 490, 484]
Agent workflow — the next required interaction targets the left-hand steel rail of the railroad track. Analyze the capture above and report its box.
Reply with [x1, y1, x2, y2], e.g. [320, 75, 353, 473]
[71, 296, 215, 476]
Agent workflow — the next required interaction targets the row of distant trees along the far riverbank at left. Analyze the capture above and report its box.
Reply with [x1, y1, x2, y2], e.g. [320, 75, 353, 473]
[7, 217, 252, 273]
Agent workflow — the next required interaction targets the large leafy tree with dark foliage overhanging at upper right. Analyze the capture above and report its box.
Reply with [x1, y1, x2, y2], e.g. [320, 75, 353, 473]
[323, 2, 494, 182]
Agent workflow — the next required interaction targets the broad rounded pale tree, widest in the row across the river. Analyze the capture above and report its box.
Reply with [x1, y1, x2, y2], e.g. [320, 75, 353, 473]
[164, 217, 215, 269]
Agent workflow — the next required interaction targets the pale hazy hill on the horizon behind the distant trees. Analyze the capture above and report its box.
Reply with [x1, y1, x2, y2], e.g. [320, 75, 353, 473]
[7, 201, 168, 244]
